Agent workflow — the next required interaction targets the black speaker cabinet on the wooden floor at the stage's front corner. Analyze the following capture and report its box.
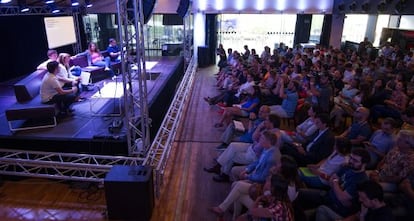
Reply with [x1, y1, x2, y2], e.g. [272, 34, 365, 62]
[104, 165, 154, 221]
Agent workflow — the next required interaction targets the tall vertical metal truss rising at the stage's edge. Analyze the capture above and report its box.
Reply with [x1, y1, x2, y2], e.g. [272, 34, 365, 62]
[117, 0, 151, 155]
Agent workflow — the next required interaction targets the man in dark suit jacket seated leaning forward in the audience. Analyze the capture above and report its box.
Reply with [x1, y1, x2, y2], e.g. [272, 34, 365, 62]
[281, 114, 335, 167]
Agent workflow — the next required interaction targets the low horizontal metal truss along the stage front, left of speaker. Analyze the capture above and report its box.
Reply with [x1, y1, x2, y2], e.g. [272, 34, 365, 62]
[0, 149, 144, 183]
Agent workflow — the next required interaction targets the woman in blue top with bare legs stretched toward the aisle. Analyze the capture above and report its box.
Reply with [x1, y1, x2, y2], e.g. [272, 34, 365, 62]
[214, 88, 260, 127]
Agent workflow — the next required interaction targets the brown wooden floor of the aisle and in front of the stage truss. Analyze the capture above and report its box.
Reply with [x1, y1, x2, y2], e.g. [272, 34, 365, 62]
[0, 67, 234, 221]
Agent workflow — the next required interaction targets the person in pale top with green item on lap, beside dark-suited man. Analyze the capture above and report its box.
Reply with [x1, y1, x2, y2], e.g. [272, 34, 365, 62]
[299, 137, 351, 188]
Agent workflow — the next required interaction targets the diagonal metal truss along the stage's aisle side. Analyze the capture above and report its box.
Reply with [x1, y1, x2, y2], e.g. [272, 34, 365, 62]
[143, 57, 197, 196]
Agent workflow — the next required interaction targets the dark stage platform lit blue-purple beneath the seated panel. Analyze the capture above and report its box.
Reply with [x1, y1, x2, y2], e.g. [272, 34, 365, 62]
[0, 57, 184, 155]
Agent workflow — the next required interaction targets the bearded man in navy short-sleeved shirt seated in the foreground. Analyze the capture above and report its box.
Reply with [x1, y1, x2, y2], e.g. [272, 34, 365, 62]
[297, 148, 370, 220]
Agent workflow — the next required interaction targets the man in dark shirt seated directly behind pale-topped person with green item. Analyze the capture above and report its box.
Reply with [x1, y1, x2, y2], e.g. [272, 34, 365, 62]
[339, 107, 371, 147]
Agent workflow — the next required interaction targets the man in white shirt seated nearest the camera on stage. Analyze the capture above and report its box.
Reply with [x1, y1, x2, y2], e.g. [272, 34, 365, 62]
[40, 61, 78, 116]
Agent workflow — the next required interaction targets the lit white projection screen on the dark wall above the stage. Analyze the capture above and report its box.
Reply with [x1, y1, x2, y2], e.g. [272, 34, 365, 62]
[44, 16, 76, 49]
